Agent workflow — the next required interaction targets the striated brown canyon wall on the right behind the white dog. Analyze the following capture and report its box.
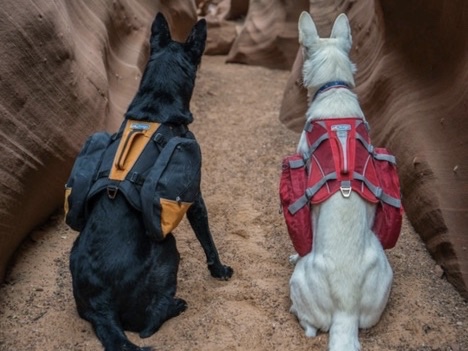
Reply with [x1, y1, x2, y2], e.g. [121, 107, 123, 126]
[278, 0, 468, 298]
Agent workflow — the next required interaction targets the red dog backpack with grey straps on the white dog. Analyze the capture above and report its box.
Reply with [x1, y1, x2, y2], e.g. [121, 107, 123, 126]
[280, 118, 403, 256]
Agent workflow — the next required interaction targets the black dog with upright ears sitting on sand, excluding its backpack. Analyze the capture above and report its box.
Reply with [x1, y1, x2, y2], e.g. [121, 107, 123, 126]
[70, 14, 233, 351]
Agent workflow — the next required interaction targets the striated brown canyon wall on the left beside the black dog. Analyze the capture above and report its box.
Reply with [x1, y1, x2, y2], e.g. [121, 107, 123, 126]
[0, 0, 197, 281]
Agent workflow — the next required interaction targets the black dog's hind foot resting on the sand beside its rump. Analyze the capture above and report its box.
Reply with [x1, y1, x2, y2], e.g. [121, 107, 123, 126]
[139, 295, 187, 338]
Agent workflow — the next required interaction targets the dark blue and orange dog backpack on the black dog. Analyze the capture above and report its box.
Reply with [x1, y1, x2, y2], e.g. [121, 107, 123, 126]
[66, 120, 201, 240]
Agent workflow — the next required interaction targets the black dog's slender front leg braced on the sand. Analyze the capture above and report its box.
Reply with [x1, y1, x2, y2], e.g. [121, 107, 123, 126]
[187, 194, 233, 280]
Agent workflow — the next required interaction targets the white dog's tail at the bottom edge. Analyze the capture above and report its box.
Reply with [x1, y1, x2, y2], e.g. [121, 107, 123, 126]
[328, 312, 361, 351]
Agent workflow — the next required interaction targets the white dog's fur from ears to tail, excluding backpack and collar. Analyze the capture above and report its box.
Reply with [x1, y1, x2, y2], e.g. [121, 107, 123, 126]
[290, 12, 393, 351]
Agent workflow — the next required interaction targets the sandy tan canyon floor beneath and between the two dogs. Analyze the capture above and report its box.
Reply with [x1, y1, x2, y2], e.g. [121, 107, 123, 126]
[0, 56, 468, 351]
